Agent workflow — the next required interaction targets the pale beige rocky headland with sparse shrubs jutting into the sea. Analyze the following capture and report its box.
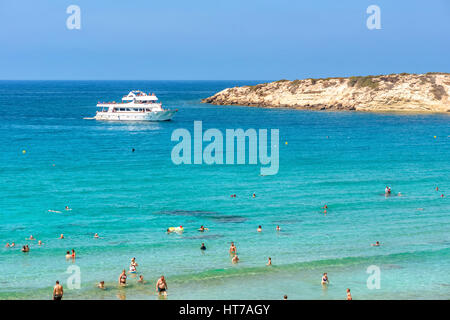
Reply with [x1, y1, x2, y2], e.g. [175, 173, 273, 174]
[202, 72, 450, 113]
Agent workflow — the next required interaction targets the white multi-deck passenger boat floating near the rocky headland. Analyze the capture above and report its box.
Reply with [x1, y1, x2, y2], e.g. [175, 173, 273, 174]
[91, 90, 178, 121]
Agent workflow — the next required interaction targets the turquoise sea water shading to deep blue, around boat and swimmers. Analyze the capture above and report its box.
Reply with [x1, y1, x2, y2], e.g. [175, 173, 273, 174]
[0, 81, 450, 299]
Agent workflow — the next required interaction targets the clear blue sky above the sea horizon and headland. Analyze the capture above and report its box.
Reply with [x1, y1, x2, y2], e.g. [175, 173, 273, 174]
[0, 0, 450, 80]
